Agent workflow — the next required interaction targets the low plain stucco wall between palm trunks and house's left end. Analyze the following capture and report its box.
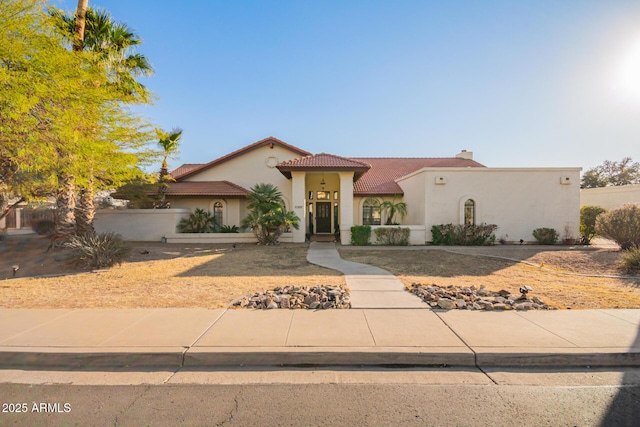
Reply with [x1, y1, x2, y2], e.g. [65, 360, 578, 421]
[94, 209, 189, 242]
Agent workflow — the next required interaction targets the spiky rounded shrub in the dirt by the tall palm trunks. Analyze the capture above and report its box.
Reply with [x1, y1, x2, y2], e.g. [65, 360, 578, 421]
[63, 233, 131, 269]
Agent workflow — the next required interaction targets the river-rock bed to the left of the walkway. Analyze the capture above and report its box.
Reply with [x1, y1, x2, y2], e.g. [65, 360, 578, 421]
[231, 286, 351, 310]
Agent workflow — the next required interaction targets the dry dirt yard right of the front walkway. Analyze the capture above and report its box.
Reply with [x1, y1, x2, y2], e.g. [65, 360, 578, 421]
[340, 246, 640, 309]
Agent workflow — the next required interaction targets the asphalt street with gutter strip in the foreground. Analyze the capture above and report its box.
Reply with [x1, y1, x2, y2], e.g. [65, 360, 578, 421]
[0, 368, 640, 426]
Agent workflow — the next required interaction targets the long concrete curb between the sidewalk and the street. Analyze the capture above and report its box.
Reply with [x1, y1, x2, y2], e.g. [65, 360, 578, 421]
[0, 347, 640, 371]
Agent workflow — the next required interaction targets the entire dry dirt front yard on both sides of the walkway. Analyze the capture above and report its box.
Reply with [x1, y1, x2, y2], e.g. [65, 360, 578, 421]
[0, 235, 640, 309]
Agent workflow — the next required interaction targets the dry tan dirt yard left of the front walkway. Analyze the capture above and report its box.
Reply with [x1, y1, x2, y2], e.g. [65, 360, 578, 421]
[0, 235, 344, 308]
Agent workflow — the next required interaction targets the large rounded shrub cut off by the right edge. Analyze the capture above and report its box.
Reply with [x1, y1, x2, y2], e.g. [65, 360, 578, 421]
[596, 204, 640, 250]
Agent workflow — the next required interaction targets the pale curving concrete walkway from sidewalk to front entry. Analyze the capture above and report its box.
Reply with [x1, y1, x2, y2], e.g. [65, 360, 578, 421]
[307, 242, 429, 309]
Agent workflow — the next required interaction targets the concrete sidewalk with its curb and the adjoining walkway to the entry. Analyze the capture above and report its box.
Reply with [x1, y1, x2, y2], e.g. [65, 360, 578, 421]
[0, 243, 640, 370]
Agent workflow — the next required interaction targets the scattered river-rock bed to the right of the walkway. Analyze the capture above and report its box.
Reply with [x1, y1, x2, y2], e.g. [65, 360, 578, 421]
[410, 283, 555, 310]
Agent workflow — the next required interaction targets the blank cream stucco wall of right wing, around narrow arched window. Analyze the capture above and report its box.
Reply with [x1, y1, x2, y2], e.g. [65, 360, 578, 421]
[398, 168, 580, 242]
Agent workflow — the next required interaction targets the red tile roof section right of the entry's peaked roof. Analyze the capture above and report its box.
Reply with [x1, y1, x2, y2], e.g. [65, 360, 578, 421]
[351, 157, 484, 196]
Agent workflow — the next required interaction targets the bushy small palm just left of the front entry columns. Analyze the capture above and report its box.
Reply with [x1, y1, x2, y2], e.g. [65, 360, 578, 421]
[242, 183, 300, 245]
